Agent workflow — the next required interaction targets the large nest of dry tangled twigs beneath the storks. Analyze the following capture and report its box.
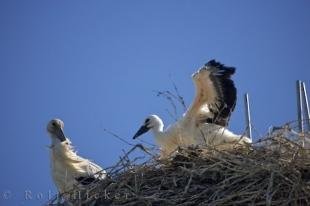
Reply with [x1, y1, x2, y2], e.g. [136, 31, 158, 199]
[47, 124, 310, 206]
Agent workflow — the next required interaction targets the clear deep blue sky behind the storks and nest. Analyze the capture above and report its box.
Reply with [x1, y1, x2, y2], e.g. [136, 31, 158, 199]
[0, 0, 310, 205]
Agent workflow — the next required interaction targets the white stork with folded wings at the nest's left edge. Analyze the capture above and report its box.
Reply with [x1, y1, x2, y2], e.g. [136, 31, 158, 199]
[47, 119, 106, 198]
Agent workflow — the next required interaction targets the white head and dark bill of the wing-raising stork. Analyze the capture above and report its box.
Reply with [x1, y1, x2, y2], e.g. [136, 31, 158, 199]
[133, 114, 164, 139]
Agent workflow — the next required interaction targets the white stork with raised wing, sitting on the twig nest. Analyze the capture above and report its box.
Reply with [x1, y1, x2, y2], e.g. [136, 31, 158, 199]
[133, 60, 251, 157]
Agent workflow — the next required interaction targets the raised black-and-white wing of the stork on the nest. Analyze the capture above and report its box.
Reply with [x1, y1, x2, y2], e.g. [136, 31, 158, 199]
[185, 60, 237, 126]
